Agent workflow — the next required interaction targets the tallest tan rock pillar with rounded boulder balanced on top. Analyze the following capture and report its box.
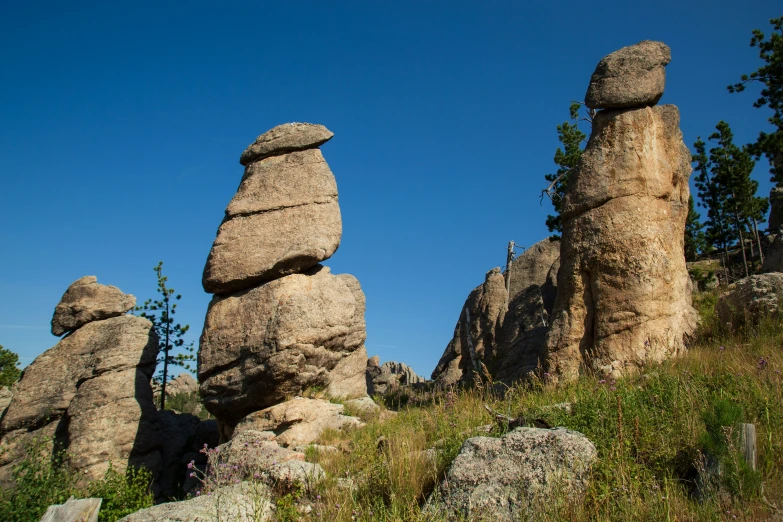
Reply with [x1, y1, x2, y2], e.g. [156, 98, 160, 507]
[547, 41, 696, 380]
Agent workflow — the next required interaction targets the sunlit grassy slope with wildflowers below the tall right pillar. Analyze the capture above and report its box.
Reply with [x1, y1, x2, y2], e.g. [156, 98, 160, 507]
[292, 293, 783, 521]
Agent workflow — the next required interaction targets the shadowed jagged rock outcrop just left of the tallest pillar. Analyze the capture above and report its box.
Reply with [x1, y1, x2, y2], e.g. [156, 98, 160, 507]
[432, 239, 560, 385]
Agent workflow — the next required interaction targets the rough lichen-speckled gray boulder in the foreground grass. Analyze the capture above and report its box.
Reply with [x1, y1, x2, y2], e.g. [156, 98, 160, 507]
[426, 428, 597, 522]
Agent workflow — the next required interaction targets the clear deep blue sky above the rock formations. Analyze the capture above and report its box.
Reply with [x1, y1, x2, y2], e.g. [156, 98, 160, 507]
[0, 0, 783, 376]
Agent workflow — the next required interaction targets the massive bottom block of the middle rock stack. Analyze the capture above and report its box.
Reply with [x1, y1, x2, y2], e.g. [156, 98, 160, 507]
[198, 266, 367, 426]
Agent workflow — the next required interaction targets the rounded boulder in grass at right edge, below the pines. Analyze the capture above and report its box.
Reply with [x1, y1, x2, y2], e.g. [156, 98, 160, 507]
[715, 272, 783, 328]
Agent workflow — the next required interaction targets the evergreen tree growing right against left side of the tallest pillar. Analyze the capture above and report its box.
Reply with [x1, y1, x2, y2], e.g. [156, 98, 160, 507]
[544, 102, 592, 232]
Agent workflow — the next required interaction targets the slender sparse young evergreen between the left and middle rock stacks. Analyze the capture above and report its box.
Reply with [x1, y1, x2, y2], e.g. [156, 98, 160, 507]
[136, 261, 195, 410]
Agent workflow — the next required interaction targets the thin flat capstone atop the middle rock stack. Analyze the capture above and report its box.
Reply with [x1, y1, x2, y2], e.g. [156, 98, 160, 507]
[239, 123, 334, 165]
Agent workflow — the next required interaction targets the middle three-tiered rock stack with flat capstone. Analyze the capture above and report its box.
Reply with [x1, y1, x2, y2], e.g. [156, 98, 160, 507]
[198, 123, 367, 430]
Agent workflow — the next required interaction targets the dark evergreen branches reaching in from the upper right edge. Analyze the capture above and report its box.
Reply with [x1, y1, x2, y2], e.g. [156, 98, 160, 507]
[728, 16, 783, 186]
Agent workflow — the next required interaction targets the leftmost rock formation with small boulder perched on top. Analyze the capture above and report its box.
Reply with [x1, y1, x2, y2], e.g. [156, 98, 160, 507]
[0, 276, 161, 483]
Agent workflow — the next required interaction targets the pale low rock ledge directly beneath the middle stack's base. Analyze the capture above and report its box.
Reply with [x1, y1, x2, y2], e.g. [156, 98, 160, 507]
[231, 397, 364, 448]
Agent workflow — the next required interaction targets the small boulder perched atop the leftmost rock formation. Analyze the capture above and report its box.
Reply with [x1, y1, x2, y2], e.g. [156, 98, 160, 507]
[52, 276, 136, 336]
